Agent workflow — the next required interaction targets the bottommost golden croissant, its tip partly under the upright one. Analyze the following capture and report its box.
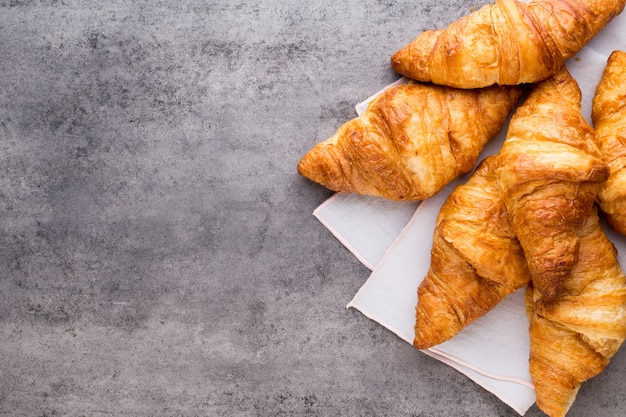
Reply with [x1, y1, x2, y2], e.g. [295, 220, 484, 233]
[526, 210, 626, 417]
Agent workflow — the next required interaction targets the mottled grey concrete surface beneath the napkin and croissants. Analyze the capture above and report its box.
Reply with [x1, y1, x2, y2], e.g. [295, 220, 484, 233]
[0, 0, 626, 417]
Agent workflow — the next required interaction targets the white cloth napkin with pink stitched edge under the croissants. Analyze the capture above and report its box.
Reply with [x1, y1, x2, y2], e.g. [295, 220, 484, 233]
[313, 13, 626, 415]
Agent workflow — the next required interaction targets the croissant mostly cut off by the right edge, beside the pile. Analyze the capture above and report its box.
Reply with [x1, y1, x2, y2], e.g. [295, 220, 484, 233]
[591, 51, 626, 235]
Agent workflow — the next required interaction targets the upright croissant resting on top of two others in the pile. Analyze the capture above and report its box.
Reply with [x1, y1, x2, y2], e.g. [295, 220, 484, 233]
[497, 68, 609, 297]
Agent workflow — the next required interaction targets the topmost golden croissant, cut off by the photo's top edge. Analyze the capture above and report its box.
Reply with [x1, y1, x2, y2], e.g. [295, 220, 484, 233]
[391, 0, 626, 88]
